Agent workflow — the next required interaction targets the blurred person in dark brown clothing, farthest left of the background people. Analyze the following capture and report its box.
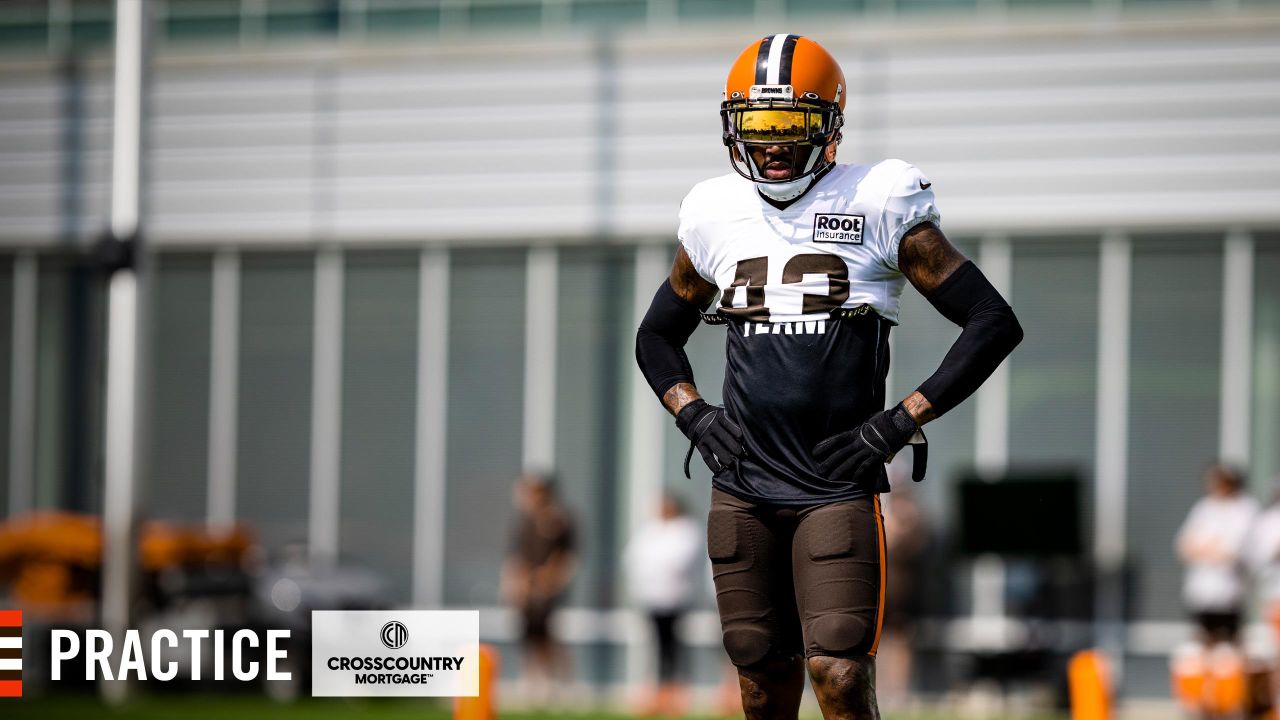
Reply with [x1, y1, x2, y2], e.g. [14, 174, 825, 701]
[502, 473, 576, 703]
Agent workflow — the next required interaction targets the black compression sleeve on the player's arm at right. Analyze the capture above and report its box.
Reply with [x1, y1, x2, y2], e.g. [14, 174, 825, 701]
[918, 263, 1023, 416]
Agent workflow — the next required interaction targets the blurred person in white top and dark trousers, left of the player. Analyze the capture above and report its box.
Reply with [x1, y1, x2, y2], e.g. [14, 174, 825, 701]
[625, 492, 703, 716]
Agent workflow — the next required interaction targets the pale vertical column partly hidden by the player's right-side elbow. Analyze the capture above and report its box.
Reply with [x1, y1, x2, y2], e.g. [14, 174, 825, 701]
[974, 236, 1014, 474]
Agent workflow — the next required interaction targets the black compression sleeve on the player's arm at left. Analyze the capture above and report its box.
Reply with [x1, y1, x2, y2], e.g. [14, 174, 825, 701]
[636, 281, 701, 400]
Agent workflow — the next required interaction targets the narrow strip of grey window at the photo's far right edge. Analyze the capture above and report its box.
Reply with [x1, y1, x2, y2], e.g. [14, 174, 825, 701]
[1249, 234, 1280, 497]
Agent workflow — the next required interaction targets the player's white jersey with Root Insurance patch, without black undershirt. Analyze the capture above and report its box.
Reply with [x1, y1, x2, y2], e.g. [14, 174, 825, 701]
[678, 160, 938, 323]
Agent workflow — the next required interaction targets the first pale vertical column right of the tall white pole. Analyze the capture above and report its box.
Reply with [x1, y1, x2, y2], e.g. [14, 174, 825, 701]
[206, 249, 241, 529]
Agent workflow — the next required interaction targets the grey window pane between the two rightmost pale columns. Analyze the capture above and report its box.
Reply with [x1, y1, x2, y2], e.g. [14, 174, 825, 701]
[1126, 237, 1222, 620]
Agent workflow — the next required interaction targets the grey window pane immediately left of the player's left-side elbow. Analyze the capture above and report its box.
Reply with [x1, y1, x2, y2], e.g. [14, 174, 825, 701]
[556, 249, 635, 607]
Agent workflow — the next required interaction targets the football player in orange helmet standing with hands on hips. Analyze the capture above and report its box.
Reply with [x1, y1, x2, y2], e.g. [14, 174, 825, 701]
[636, 35, 1023, 720]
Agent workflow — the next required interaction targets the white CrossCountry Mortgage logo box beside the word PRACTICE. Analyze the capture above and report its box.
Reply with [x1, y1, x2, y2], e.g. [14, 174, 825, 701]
[311, 610, 480, 697]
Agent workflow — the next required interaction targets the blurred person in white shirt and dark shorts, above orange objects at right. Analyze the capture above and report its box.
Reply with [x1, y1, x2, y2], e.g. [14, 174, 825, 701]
[1178, 465, 1258, 646]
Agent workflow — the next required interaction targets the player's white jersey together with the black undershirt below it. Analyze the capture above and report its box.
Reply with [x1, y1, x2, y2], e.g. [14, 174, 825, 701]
[680, 160, 938, 505]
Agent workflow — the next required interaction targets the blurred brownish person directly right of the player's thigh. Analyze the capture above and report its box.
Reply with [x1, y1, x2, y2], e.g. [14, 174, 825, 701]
[876, 484, 929, 707]
